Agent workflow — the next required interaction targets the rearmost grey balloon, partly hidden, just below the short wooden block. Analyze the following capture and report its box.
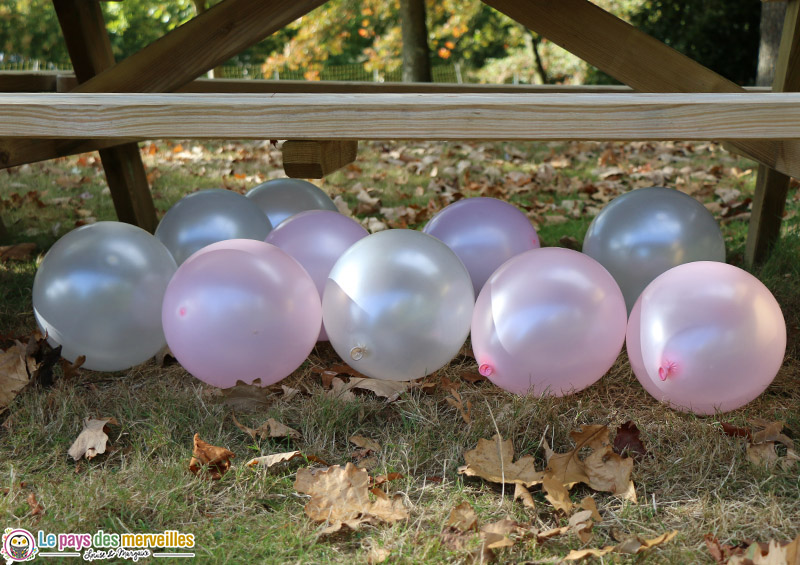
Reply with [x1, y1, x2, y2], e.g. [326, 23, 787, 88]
[245, 179, 339, 227]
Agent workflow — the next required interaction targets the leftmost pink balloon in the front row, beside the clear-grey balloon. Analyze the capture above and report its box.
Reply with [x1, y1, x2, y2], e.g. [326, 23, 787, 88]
[161, 245, 322, 388]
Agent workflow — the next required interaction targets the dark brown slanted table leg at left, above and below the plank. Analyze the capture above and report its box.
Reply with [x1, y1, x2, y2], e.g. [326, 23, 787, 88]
[53, 0, 158, 233]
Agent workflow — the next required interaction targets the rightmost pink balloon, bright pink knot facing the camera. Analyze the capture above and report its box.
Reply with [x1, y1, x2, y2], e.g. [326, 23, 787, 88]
[627, 261, 786, 414]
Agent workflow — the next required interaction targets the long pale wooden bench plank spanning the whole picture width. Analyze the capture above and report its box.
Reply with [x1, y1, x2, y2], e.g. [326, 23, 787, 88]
[0, 93, 800, 140]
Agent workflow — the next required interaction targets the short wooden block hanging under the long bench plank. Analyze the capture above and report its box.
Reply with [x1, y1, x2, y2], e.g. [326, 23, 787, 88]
[281, 140, 358, 179]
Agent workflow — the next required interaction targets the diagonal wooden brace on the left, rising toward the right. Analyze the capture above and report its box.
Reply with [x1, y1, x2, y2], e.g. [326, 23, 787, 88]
[0, 0, 325, 168]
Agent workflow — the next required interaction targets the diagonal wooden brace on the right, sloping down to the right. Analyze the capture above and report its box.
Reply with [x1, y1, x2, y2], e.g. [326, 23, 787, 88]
[484, 0, 800, 176]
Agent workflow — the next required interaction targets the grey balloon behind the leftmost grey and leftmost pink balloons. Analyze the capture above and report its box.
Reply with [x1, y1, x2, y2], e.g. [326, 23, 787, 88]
[155, 188, 272, 265]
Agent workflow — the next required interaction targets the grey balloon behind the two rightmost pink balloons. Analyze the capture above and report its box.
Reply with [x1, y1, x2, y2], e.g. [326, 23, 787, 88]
[583, 187, 725, 314]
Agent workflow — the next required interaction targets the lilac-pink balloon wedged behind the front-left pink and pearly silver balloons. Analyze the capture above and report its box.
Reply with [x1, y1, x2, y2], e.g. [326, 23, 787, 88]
[266, 210, 369, 341]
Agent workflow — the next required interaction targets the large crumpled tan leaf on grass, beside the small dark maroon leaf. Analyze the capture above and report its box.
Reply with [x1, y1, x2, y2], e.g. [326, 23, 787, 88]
[545, 425, 636, 502]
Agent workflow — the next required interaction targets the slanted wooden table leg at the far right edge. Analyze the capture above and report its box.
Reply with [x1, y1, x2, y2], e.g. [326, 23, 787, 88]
[745, 0, 800, 266]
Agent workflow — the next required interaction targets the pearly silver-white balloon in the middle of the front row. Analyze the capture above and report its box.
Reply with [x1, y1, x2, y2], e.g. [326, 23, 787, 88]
[322, 230, 475, 381]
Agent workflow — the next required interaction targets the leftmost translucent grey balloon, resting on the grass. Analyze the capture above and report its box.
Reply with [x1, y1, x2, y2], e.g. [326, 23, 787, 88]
[33, 222, 177, 371]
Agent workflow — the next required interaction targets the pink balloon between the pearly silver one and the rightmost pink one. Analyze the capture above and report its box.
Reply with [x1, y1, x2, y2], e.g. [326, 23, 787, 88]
[472, 247, 627, 396]
